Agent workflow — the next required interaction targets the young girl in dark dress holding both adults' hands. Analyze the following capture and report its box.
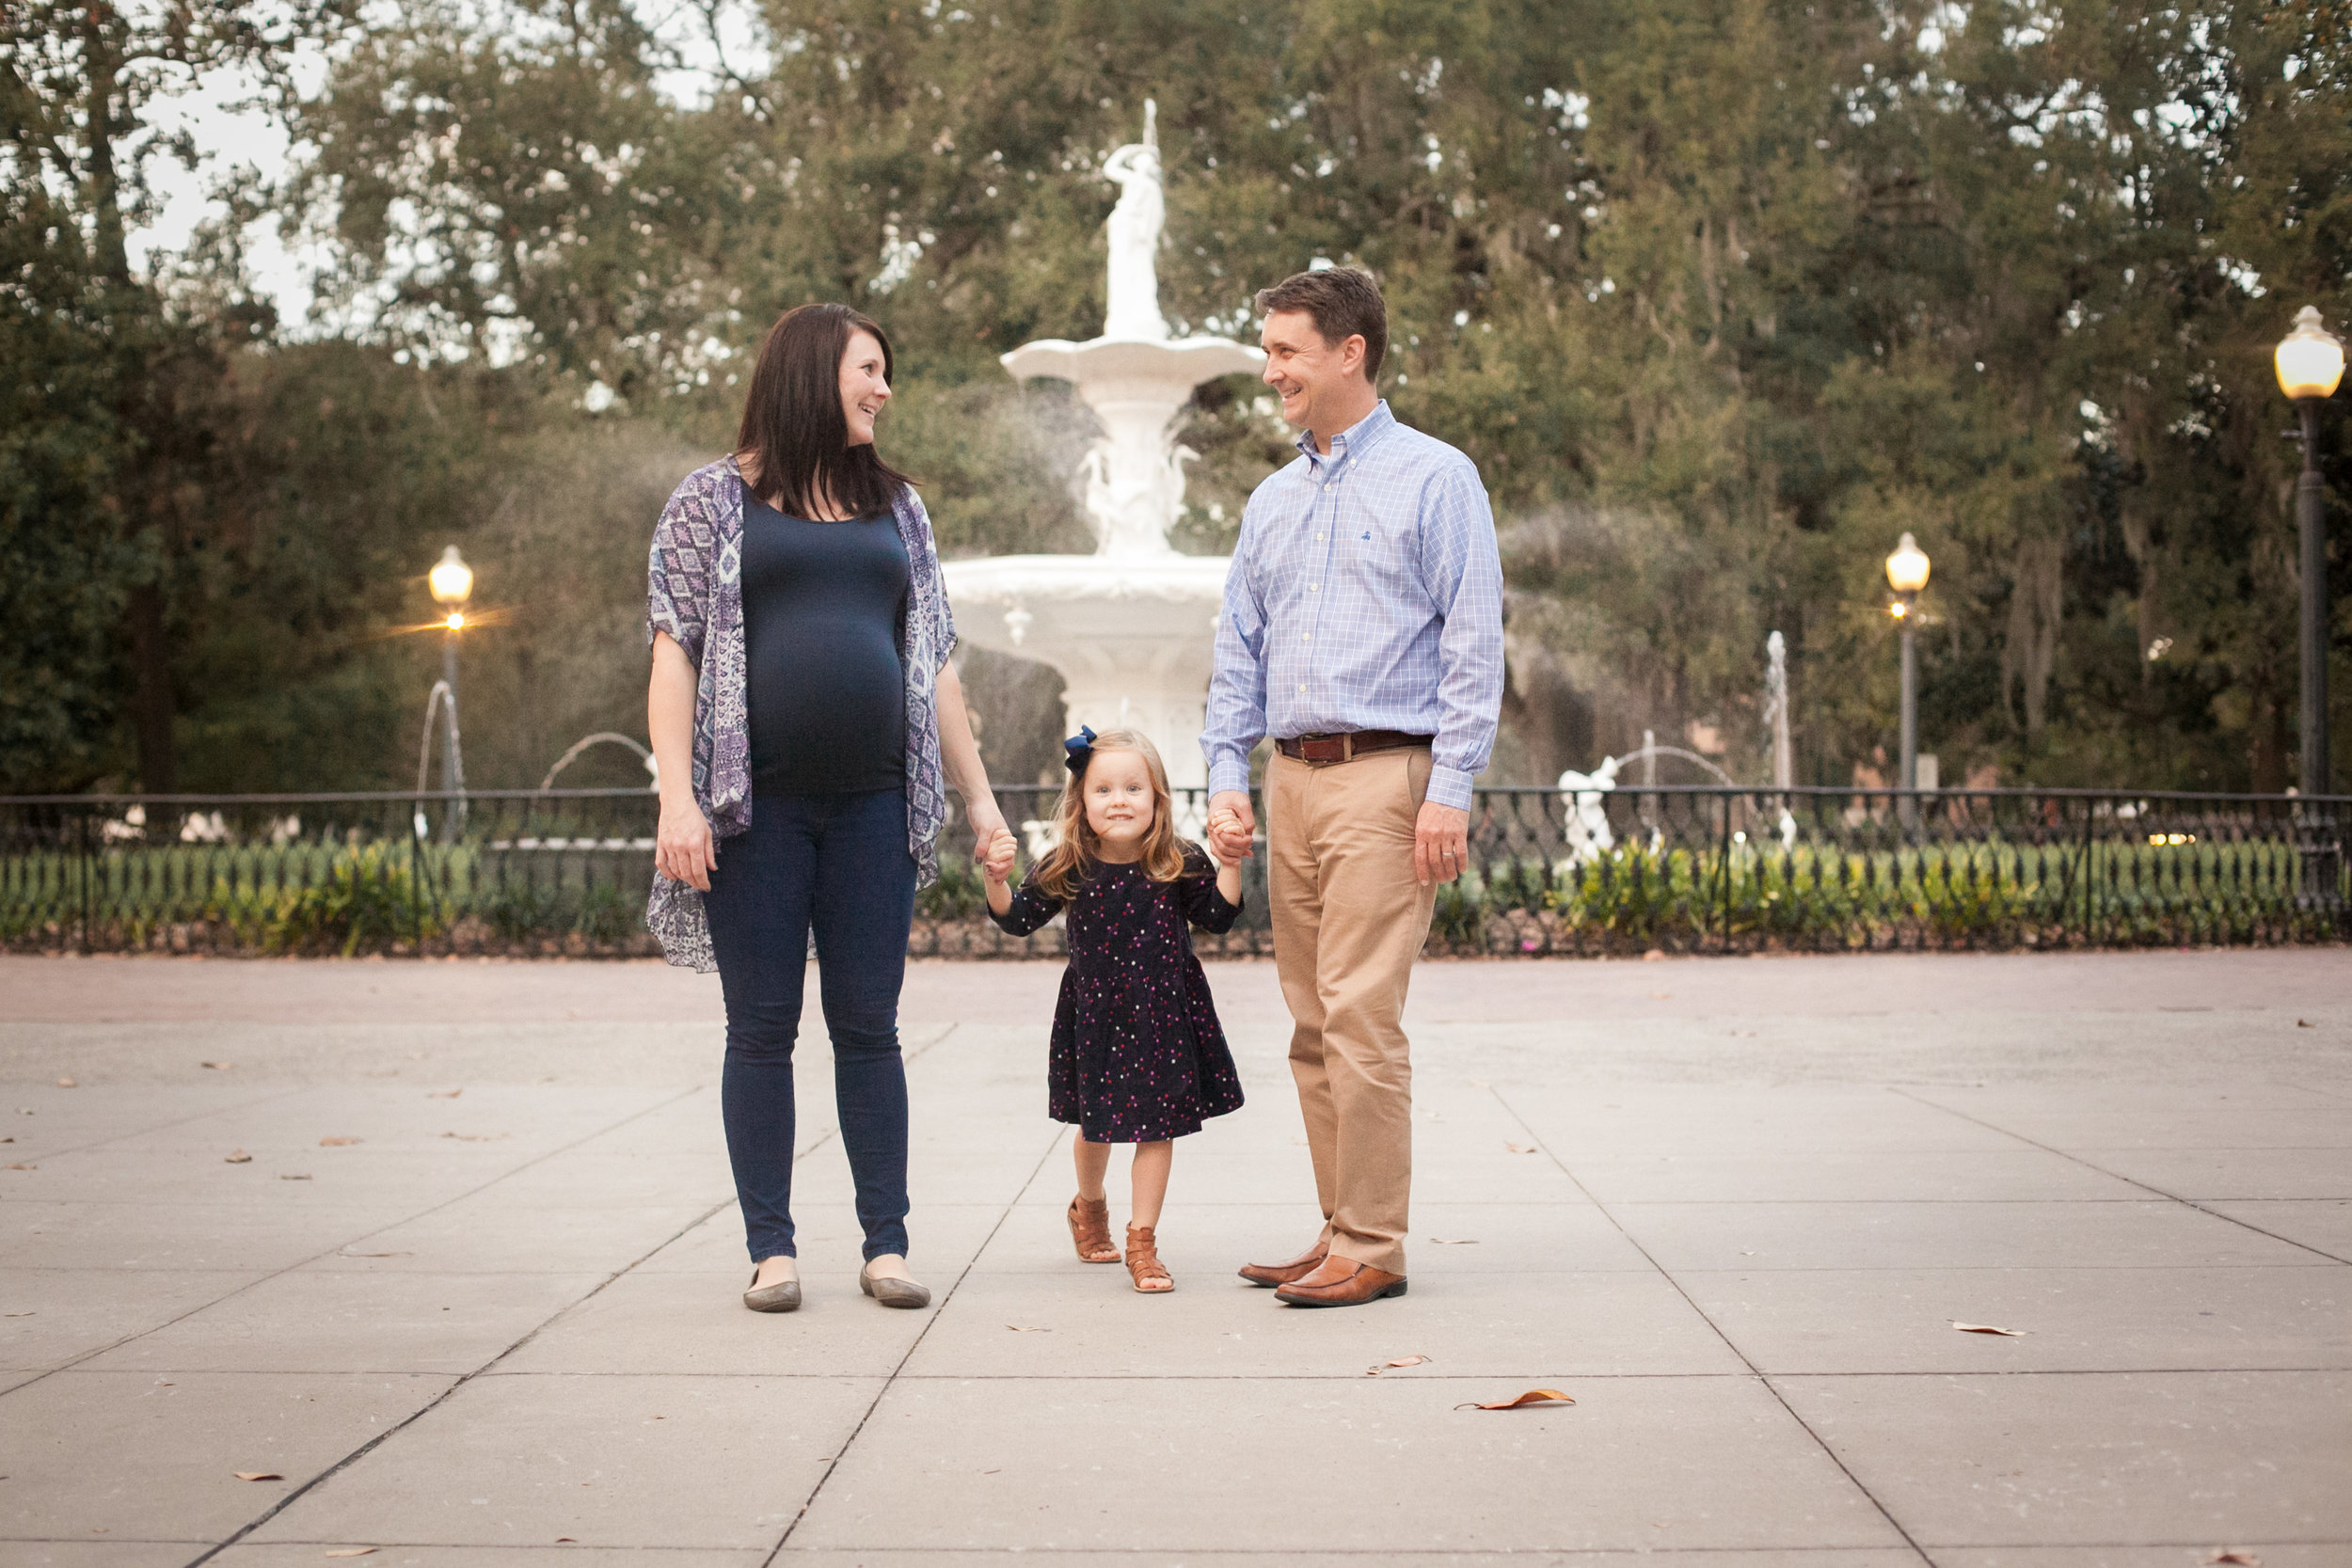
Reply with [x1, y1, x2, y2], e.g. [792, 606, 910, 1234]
[983, 729, 1242, 1293]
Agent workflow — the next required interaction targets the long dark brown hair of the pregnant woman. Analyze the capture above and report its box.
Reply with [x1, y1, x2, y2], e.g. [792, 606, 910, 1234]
[737, 306, 913, 517]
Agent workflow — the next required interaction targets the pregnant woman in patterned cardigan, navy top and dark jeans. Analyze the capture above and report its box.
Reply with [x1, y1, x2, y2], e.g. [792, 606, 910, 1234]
[644, 306, 1009, 1312]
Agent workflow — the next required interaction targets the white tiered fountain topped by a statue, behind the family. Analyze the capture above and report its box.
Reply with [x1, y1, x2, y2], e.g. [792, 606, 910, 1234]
[946, 103, 1265, 787]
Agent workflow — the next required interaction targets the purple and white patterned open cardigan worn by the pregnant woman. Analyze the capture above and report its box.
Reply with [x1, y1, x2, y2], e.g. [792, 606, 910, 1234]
[644, 458, 955, 974]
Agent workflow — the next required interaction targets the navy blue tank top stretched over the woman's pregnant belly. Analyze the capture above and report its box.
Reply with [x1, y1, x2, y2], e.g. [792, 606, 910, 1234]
[739, 480, 908, 795]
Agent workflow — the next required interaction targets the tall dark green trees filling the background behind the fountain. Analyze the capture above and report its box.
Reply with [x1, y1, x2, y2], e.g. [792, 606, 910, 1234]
[0, 0, 2352, 790]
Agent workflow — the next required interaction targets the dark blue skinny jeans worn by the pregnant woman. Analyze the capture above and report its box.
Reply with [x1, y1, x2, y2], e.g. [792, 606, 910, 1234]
[704, 790, 915, 1262]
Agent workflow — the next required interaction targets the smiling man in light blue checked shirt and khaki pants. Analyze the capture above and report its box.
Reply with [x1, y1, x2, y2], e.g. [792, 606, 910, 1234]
[1202, 268, 1503, 1307]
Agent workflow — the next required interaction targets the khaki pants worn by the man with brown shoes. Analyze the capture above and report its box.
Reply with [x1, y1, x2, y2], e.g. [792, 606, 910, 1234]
[1265, 748, 1438, 1275]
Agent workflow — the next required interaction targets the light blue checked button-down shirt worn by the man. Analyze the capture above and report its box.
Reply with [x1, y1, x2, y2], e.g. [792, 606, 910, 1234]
[1200, 400, 1503, 811]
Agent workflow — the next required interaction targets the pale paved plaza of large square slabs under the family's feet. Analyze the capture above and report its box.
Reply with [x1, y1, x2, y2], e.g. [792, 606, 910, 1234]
[0, 950, 2352, 1568]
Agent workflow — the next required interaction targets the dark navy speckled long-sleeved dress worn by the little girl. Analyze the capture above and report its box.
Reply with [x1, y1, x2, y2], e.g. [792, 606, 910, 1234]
[995, 844, 1242, 1143]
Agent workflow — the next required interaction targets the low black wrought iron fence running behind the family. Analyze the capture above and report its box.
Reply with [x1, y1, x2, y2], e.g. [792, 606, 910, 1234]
[0, 785, 2352, 957]
